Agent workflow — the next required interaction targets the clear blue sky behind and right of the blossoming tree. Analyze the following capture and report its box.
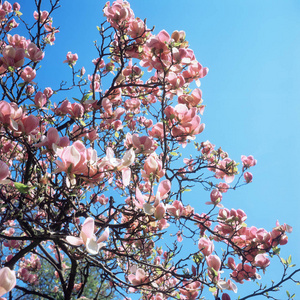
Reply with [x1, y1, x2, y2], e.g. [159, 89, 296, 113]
[20, 0, 300, 299]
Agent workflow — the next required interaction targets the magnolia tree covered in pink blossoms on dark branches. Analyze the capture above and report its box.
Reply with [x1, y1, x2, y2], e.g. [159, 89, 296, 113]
[0, 0, 299, 300]
